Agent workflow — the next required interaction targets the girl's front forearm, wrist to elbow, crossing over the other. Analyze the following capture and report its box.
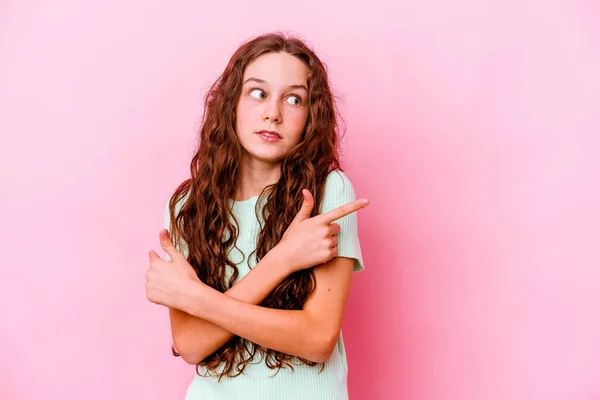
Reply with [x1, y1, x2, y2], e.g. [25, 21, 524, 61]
[186, 284, 336, 362]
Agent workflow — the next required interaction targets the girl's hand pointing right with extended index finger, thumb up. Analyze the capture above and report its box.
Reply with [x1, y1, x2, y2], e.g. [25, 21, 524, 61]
[272, 189, 369, 273]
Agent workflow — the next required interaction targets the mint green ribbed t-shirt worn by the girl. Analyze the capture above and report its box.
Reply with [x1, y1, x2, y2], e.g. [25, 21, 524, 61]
[165, 170, 364, 400]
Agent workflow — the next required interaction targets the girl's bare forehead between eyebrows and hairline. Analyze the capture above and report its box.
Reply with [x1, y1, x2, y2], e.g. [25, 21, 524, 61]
[243, 52, 309, 85]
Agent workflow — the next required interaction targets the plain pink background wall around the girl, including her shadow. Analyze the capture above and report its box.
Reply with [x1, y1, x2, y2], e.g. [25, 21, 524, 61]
[0, 0, 600, 400]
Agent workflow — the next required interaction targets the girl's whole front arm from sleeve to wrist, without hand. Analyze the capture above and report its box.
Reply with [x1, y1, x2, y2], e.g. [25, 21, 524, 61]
[177, 257, 354, 362]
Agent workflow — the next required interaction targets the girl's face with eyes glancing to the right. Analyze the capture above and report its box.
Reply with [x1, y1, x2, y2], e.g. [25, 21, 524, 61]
[236, 52, 309, 164]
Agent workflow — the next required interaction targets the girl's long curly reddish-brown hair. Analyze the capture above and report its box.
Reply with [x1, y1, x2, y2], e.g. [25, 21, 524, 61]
[169, 33, 342, 380]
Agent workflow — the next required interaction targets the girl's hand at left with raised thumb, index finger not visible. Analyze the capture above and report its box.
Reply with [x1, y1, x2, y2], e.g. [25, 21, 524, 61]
[146, 229, 203, 309]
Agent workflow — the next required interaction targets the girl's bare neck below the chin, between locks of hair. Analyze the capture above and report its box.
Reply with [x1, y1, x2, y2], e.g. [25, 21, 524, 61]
[235, 155, 281, 201]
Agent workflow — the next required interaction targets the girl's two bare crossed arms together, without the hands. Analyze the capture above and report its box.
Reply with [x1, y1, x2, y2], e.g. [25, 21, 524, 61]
[169, 252, 354, 365]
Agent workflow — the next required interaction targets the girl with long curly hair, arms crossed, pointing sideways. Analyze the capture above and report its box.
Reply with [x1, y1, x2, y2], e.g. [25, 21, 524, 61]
[146, 34, 368, 400]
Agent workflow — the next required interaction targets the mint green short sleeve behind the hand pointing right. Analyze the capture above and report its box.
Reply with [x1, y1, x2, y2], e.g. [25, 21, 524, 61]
[320, 170, 364, 272]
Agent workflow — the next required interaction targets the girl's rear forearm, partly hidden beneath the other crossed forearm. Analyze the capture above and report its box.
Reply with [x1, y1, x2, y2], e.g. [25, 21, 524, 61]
[169, 251, 288, 364]
